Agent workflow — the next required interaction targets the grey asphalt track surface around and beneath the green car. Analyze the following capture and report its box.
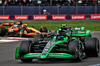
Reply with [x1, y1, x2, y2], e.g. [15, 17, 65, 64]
[0, 31, 100, 66]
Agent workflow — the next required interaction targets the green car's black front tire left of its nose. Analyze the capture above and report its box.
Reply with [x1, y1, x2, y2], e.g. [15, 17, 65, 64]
[19, 40, 33, 62]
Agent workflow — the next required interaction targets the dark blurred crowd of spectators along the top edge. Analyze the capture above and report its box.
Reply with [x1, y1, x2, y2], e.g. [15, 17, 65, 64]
[0, 0, 100, 6]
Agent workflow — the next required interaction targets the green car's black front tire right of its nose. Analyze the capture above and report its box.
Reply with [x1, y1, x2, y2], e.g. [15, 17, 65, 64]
[68, 40, 83, 62]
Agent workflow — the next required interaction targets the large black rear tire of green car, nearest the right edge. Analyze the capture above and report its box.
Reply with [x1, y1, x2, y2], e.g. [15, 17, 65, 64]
[85, 37, 99, 57]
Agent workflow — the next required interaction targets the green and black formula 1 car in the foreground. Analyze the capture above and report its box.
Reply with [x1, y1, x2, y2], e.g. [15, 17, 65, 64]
[15, 26, 99, 62]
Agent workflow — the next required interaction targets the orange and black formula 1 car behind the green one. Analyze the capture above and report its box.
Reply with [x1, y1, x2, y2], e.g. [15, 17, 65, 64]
[0, 21, 48, 37]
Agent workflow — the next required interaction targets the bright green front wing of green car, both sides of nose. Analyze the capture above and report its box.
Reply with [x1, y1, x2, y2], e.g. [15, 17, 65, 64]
[23, 53, 74, 59]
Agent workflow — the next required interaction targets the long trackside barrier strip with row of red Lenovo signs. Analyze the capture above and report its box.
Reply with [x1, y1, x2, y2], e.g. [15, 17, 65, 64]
[0, 14, 100, 20]
